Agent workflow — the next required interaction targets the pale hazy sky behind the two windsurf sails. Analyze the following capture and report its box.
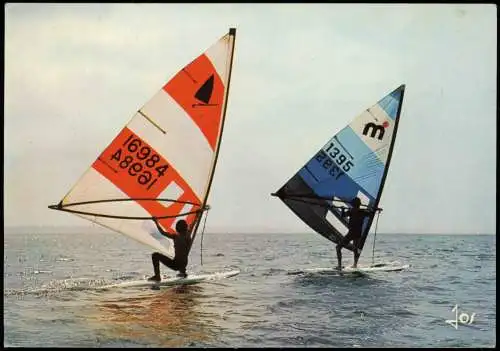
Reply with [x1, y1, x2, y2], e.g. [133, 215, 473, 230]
[4, 3, 497, 234]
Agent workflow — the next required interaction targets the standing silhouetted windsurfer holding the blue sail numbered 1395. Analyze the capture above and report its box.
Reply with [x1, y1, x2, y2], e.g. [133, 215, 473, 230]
[337, 197, 375, 270]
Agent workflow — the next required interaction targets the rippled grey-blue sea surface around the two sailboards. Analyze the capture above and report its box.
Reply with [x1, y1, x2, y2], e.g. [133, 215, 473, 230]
[3, 232, 496, 347]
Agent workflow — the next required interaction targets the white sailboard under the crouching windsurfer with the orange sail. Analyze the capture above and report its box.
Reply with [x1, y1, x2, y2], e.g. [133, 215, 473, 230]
[99, 270, 240, 289]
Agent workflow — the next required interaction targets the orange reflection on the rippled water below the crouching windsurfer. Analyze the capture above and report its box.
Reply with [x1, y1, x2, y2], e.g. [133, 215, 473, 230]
[88, 285, 215, 347]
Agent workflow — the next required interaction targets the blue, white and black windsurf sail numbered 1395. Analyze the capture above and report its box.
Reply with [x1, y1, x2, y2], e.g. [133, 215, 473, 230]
[274, 85, 404, 253]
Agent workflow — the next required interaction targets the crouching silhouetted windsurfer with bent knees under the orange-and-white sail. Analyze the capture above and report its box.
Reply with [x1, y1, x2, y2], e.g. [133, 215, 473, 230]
[148, 218, 191, 282]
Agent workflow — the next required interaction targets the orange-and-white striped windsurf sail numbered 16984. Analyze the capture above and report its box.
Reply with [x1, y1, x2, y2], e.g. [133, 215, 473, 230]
[49, 28, 240, 286]
